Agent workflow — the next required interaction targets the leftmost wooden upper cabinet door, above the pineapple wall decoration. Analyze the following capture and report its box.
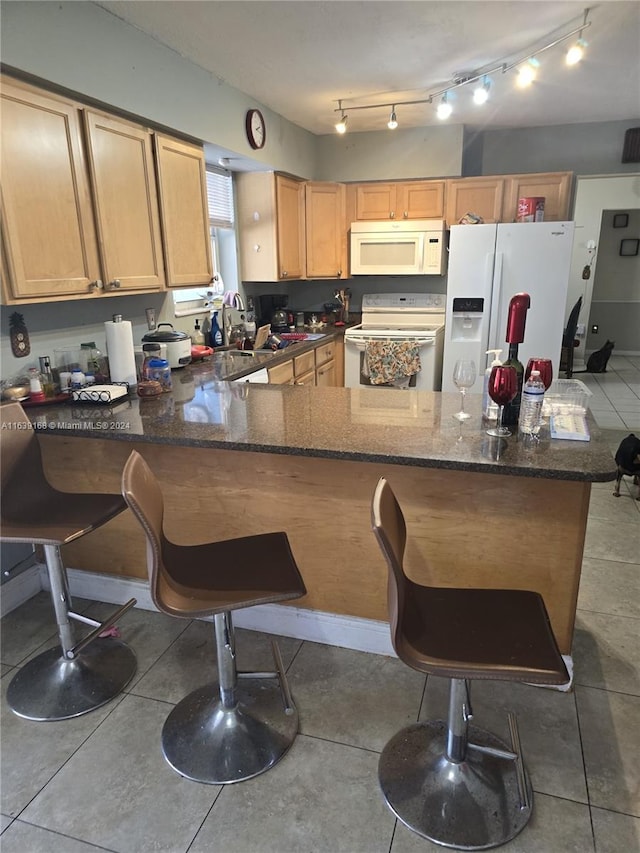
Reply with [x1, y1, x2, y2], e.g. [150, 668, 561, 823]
[1, 80, 101, 302]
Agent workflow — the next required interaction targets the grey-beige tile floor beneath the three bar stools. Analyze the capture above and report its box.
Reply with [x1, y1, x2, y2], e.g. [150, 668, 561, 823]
[0, 358, 640, 853]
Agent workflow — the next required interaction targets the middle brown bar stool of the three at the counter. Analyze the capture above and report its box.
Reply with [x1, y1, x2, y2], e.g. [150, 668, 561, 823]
[122, 450, 306, 785]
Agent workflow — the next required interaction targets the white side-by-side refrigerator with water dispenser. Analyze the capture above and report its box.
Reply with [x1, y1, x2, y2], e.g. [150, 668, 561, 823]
[442, 222, 574, 394]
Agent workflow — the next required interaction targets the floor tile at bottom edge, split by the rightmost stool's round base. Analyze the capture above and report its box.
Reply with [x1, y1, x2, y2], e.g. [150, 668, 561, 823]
[391, 794, 596, 853]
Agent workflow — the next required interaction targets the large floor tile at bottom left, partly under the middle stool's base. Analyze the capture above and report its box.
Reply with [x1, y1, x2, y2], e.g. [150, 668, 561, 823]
[21, 696, 219, 853]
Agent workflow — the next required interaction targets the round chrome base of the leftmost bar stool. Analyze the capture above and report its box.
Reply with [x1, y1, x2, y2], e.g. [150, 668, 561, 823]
[7, 637, 137, 722]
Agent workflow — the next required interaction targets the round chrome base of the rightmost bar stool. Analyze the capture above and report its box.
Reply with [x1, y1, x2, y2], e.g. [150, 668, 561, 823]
[378, 721, 533, 850]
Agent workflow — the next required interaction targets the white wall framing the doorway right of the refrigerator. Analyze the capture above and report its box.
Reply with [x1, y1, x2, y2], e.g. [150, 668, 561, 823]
[567, 172, 640, 361]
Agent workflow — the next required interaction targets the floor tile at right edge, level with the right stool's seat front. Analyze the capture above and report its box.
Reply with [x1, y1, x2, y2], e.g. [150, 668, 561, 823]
[572, 610, 640, 696]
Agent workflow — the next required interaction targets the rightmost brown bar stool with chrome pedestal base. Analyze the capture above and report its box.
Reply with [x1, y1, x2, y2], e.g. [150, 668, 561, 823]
[372, 478, 569, 850]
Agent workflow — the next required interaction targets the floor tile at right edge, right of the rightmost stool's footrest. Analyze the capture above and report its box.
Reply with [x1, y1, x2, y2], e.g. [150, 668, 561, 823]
[576, 687, 640, 817]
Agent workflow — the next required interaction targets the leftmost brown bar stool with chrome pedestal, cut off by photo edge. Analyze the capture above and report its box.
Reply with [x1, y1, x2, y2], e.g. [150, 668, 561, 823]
[0, 403, 136, 721]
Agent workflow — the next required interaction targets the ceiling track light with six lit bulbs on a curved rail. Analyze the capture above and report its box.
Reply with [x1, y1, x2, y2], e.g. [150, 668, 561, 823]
[334, 8, 591, 133]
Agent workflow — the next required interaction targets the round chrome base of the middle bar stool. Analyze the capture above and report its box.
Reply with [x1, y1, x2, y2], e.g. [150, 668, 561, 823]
[162, 679, 298, 785]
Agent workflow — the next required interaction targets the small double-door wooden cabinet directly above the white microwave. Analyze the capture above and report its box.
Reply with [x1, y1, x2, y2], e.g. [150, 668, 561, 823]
[355, 181, 445, 220]
